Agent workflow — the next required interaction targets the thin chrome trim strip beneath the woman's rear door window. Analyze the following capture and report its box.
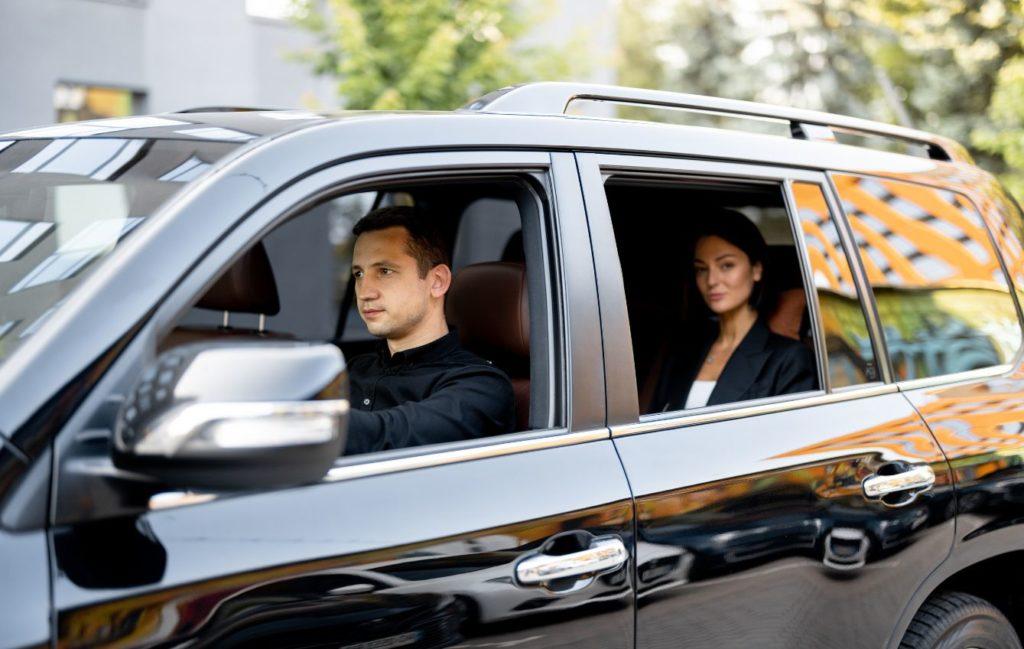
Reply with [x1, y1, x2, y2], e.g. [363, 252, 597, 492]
[611, 383, 897, 437]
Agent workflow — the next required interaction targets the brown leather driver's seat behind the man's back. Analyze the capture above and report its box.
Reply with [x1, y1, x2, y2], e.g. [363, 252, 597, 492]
[444, 257, 529, 430]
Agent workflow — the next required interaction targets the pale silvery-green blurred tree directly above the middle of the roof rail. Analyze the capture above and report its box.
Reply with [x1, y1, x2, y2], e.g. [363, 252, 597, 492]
[620, 0, 900, 119]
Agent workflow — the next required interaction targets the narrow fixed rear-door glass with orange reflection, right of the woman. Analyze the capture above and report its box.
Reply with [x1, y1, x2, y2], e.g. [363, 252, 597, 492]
[793, 182, 881, 388]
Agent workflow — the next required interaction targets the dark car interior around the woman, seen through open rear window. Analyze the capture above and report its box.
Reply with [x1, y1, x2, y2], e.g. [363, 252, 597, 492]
[605, 176, 814, 415]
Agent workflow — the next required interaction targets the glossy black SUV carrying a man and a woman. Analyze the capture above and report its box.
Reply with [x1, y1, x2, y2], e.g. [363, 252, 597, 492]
[0, 84, 1024, 649]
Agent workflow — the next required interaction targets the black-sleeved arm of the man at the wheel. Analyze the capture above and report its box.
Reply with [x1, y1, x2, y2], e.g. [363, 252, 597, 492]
[345, 365, 515, 456]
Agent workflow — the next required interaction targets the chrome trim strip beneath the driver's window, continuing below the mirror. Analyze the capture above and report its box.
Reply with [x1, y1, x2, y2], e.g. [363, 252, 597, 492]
[148, 428, 609, 511]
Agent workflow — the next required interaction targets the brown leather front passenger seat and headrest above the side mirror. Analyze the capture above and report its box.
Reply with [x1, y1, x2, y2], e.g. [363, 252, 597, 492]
[160, 243, 292, 351]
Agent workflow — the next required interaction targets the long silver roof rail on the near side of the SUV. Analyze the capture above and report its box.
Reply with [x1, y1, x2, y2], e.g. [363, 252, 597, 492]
[461, 82, 974, 164]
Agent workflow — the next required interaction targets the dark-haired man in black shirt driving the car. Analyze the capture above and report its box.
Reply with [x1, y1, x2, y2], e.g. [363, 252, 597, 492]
[345, 207, 515, 455]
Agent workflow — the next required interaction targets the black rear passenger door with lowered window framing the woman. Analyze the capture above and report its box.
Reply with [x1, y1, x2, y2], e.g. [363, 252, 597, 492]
[579, 155, 953, 647]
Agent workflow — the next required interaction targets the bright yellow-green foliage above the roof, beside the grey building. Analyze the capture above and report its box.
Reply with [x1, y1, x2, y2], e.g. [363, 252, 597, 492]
[299, 0, 582, 110]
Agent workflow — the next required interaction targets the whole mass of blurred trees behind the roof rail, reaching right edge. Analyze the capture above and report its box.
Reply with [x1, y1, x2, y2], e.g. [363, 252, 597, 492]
[620, 0, 1024, 196]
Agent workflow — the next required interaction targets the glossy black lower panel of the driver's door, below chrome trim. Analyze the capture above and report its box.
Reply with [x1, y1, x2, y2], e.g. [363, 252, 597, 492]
[54, 441, 633, 647]
